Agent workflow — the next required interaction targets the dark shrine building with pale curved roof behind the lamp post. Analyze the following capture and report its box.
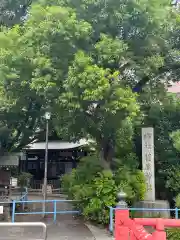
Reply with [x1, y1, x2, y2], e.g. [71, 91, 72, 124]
[19, 140, 87, 189]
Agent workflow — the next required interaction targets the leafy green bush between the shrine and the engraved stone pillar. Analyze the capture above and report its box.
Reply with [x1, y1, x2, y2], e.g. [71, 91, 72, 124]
[62, 156, 145, 224]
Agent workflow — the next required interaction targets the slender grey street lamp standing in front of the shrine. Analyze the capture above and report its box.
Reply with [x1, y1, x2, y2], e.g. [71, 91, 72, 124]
[43, 112, 51, 217]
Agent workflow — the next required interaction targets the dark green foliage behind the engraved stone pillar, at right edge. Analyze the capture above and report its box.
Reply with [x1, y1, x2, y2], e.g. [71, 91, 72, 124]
[136, 94, 180, 201]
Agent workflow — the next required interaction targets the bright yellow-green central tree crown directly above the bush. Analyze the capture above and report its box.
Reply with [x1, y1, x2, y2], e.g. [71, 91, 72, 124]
[59, 51, 139, 161]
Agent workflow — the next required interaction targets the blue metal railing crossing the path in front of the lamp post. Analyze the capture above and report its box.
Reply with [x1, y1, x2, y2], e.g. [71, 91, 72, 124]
[12, 199, 80, 222]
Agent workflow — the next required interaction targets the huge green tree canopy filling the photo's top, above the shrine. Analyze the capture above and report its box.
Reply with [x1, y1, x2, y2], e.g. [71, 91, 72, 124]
[0, 0, 179, 171]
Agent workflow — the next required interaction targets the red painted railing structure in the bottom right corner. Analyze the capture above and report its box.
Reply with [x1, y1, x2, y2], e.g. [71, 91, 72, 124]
[115, 209, 180, 240]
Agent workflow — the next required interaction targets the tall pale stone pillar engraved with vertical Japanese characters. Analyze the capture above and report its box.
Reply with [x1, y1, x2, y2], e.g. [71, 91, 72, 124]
[142, 127, 155, 201]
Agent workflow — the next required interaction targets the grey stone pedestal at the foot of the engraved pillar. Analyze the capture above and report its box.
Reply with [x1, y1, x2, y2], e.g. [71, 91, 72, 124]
[132, 200, 171, 218]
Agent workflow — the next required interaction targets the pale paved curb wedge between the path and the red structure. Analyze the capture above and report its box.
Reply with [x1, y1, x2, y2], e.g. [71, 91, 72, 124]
[85, 223, 114, 240]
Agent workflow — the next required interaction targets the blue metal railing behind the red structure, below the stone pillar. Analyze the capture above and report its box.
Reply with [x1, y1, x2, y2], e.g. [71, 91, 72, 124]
[109, 207, 180, 233]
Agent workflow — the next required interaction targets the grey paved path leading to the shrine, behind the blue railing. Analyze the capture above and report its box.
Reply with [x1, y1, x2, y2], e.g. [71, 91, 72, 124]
[0, 196, 95, 240]
